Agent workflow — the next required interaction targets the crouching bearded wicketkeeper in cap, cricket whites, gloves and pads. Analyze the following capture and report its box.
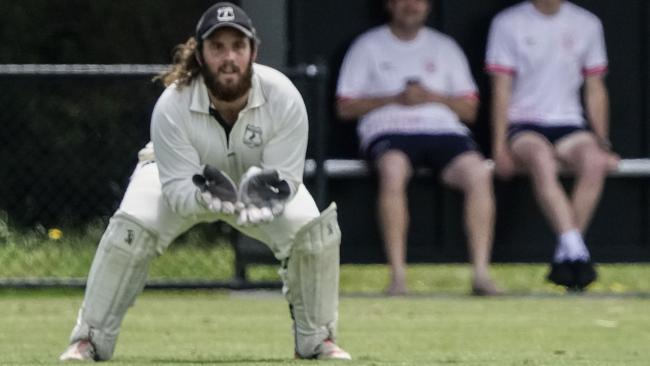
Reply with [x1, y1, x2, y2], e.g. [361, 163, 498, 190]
[60, 3, 350, 361]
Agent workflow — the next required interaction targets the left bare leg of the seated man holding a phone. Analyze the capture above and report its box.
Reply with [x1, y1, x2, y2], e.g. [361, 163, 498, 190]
[377, 150, 412, 295]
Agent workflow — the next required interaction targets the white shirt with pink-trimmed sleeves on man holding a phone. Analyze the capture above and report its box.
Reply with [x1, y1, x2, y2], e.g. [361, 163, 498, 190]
[337, 25, 478, 148]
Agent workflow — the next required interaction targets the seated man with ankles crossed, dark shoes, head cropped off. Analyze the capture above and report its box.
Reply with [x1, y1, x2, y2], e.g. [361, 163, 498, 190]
[486, 0, 618, 290]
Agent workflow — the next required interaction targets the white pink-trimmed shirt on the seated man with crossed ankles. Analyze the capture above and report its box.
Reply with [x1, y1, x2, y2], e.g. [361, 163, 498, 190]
[486, 1, 607, 126]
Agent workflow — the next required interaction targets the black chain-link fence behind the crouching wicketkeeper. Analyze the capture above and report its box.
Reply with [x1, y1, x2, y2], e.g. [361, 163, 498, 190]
[0, 64, 327, 288]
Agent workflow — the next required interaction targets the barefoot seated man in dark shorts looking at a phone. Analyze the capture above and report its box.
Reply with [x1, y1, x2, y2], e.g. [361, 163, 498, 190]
[337, 0, 500, 295]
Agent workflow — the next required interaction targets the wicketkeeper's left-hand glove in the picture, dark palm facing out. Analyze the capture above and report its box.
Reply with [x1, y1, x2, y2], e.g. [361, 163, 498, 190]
[192, 165, 237, 215]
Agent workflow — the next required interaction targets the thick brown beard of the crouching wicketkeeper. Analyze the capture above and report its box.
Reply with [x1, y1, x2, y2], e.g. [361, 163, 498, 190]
[201, 60, 253, 102]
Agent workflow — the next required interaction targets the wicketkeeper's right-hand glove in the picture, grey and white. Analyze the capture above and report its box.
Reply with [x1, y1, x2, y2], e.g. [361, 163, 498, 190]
[237, 167, 291, 225]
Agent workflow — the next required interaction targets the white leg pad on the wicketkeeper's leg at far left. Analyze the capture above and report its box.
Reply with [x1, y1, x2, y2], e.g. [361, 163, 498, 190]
[70, 211, 159, 360]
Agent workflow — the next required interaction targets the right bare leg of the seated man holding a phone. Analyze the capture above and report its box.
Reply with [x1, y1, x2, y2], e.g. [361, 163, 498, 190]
[442, 152, 501, 295]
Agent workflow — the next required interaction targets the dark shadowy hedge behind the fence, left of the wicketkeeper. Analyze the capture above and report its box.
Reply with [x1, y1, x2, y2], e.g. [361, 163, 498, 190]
[0, 0, 229, 226]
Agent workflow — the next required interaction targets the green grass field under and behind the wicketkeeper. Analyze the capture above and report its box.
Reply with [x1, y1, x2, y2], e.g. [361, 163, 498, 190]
[0, 222, 650, 366]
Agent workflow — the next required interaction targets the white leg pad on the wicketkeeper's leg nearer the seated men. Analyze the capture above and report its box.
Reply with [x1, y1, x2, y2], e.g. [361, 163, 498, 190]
[280, 204, 341, 358]
